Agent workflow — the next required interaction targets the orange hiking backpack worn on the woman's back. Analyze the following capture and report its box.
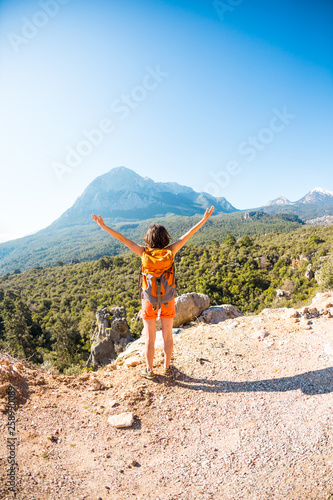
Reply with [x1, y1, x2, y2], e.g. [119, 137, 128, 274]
[139, 247, 176, 310]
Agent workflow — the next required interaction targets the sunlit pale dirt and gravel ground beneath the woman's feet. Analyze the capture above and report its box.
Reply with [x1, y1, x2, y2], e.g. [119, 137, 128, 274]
[0, 294, 333, 500]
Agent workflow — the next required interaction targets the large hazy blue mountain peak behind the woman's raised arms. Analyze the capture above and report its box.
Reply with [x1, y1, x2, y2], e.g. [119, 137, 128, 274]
[51, 167, 237, 227]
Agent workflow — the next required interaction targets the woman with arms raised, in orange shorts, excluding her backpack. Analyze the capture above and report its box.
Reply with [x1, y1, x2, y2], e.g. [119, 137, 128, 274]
[92, 207, 214, 379]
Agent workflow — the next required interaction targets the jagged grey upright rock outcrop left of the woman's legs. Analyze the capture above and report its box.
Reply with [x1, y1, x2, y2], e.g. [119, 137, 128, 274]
[87, 307, 133, 367]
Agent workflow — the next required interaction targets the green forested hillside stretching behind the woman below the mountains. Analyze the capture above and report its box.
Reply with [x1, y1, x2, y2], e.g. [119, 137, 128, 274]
[0, 225, 333, 373]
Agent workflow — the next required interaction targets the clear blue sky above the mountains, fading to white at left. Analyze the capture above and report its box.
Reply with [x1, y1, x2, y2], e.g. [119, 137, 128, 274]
[0, 0, 333, 241]
